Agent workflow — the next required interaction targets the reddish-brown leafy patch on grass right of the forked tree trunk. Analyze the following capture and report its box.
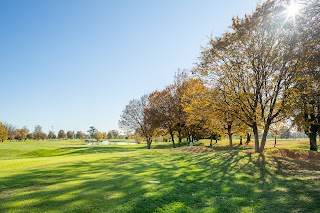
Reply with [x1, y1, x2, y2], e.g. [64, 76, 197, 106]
[266, 149, 320, 163]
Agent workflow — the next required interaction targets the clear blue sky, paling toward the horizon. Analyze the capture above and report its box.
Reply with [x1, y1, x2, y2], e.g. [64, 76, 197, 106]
[0, 0, 258, 133]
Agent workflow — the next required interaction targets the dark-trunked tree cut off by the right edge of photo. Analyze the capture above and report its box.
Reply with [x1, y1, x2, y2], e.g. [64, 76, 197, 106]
[294, 0, 320, 151]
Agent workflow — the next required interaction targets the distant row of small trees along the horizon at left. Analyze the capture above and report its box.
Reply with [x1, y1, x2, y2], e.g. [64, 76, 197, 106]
[0, 122, 120, 142]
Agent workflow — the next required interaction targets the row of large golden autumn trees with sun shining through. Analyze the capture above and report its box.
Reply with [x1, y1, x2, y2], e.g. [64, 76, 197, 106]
[119, 0, 320, 153]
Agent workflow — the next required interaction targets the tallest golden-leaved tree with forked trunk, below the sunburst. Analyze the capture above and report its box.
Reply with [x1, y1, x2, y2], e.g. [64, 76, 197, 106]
[197, 1, 301, 152]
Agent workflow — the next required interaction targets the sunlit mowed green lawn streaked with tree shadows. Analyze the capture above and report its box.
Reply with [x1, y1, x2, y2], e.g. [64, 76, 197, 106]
[0, 140, 320, 212]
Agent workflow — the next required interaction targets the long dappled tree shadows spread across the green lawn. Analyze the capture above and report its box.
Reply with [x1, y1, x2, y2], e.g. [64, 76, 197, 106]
[0, 151, 320, 212]
